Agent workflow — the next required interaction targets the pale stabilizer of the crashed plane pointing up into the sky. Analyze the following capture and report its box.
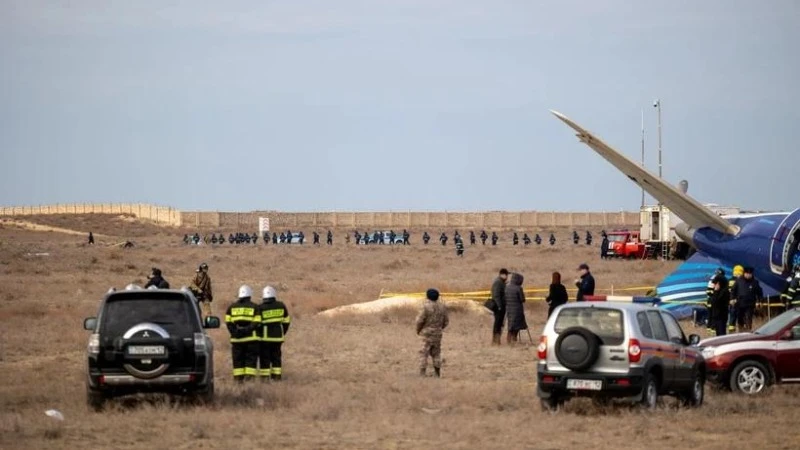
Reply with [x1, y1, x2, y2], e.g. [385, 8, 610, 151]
[550, 110, 739, 235]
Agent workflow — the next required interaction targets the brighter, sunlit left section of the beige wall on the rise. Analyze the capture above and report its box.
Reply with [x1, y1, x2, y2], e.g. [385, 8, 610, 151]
[0, 203, 181, 225]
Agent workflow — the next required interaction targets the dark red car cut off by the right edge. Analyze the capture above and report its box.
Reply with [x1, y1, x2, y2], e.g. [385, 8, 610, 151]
[698, 308, 800, 395]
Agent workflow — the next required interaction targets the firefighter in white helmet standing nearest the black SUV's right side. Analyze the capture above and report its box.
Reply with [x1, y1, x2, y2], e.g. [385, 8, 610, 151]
[225, 285, 261, 383]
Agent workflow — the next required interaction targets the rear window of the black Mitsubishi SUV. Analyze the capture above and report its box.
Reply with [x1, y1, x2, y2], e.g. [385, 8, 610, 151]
[100, 296, 197, 336]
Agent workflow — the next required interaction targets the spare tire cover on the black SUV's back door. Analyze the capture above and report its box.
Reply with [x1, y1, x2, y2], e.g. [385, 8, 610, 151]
[122, 322, 170, 379]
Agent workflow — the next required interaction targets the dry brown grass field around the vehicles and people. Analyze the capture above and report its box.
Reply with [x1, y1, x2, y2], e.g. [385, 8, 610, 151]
[0, 217, 800, 449]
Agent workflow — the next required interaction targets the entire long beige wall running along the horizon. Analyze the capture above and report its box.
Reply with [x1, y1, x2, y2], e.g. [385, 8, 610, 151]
[0, 203, 639, 230]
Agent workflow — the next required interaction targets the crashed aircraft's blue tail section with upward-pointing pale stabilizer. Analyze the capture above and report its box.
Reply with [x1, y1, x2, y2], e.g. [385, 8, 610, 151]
[550, 111, 800, 303]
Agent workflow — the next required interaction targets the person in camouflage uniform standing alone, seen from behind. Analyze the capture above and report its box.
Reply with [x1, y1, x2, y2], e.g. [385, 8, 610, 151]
[416, 289, 450, 377]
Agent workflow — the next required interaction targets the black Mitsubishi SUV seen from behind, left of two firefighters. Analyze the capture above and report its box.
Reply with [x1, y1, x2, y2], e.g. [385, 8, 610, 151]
[83, 289, 220, 410]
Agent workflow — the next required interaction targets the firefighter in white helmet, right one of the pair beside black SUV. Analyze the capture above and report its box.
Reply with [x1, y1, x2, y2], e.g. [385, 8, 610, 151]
[258, 286, 292, 381]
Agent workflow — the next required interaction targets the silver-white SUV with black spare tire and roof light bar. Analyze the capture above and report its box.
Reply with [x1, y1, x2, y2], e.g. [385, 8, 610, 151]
[537, 302, 706, 410]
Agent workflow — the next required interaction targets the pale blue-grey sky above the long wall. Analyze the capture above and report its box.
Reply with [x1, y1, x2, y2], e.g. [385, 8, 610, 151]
[0, 0, 800, 211]
